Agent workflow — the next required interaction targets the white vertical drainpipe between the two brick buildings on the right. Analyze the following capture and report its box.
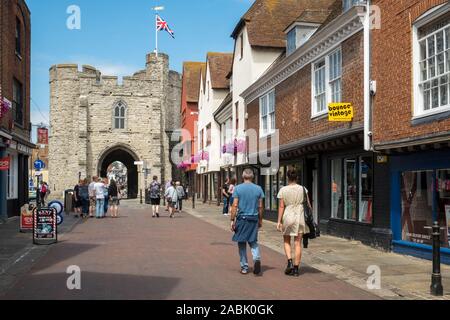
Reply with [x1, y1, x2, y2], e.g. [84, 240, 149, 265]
[364, 0, 373, 151]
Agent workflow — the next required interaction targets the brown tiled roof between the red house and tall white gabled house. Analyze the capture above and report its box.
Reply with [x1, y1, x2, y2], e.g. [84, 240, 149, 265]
[207, 52, 233, 89]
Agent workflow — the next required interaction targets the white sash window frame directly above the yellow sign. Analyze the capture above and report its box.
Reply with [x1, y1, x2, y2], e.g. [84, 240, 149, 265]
[311, 46, 343, 119]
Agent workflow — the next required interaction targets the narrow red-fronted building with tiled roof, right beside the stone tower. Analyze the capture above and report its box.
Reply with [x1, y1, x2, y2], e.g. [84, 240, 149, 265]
[181, 62, 206, 191]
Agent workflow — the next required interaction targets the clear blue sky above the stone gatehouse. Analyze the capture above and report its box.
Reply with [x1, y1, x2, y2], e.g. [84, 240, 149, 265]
[27, 0, 253, 124]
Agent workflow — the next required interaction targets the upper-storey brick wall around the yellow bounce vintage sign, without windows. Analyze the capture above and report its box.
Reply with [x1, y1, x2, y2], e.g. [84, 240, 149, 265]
[247, 32, 364, 152]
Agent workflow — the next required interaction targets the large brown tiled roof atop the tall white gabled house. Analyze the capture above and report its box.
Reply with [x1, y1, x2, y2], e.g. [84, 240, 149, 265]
[232, 0, 336, 48]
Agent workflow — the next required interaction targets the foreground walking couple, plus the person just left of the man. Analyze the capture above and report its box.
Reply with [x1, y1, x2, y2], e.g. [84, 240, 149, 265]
[229, 169, 315, 277]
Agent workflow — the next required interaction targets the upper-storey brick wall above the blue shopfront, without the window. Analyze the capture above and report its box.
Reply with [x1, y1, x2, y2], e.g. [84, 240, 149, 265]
[372, 0, 450, 144]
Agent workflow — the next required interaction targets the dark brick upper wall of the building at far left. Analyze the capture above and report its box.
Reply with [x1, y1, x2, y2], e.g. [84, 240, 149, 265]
[0, 0, 31, 137]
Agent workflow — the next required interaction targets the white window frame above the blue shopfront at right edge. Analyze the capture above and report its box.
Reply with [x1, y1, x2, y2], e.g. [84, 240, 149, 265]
[412, 8, 450, 120]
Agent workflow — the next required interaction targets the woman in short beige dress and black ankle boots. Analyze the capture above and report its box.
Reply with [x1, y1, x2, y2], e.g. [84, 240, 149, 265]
[277, 171, 311, 277]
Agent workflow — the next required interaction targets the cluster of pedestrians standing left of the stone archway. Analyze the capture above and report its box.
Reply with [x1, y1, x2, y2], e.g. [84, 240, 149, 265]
[74, 177, 121, 219]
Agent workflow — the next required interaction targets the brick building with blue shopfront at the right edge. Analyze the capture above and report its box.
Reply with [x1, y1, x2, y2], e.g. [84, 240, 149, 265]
[372, 0, 450, 262]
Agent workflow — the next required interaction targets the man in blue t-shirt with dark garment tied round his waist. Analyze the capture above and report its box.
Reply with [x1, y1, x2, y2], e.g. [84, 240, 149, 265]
[231, 169, 264, 275]
